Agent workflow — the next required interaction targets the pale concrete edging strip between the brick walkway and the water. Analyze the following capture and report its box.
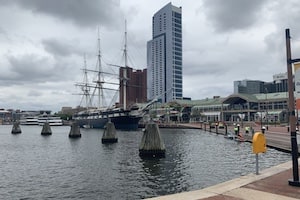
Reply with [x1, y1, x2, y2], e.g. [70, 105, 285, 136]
[149, 158, 294, 200]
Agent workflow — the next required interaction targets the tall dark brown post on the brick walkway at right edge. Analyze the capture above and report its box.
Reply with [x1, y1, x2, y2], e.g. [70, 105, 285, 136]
[285, 29, 300, 187]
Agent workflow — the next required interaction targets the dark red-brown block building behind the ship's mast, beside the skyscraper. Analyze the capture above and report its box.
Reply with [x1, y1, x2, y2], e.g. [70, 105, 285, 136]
[119, 67, 147, 107]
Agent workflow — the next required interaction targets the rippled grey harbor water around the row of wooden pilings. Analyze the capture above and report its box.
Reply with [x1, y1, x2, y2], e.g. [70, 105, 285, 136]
[0, 125, 291, 200]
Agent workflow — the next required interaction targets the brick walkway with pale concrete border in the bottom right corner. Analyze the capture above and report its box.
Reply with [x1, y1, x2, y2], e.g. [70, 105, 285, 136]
[146, 160, 300, 200]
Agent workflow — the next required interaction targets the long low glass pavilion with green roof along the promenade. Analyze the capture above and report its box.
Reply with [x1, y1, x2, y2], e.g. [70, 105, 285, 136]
[150, 92, 288, 124]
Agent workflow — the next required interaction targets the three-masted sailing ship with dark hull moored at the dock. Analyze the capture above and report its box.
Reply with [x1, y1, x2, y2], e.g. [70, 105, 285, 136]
[73, 25, 148, 130]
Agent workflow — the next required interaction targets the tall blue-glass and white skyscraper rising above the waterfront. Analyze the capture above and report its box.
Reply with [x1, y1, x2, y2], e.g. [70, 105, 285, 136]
[147, 3, 182, 102]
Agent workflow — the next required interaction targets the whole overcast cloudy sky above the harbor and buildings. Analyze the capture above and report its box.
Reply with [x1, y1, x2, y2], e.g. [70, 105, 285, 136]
[0, 0, 300, 112]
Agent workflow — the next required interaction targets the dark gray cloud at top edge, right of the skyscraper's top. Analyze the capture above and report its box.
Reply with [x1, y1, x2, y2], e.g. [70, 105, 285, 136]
[204, 0, 268, 32]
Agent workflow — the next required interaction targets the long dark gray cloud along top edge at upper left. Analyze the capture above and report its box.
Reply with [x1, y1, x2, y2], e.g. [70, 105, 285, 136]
[0, 0, 122, 28]
